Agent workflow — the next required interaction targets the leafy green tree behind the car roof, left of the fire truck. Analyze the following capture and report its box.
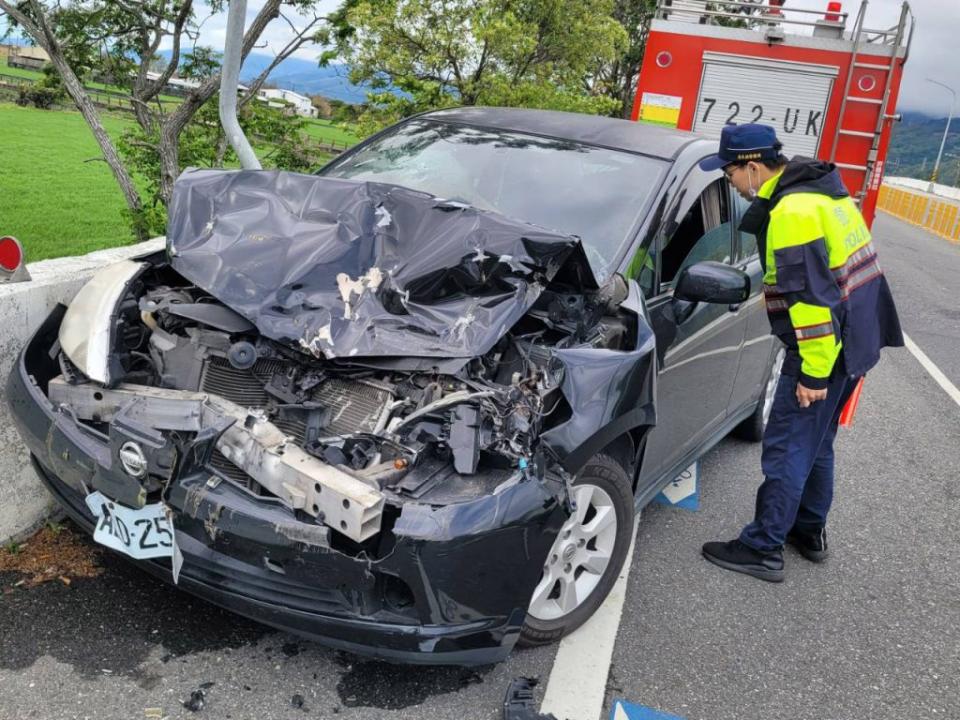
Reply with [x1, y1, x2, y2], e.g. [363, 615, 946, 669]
[321, 0, 627, 131]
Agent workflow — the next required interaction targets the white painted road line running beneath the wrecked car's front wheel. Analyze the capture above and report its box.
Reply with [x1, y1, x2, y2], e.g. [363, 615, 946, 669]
[540, 515, 640, 720]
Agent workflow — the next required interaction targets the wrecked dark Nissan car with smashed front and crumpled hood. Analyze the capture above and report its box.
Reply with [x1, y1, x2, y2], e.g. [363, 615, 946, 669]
[7, 108, 779, 664]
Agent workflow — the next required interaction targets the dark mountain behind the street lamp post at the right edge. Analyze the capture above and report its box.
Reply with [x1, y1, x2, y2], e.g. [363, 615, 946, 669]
[885, 112, 960, 185]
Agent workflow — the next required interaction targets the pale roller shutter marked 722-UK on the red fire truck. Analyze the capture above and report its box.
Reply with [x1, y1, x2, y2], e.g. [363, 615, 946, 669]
[693, 52, 839, 157]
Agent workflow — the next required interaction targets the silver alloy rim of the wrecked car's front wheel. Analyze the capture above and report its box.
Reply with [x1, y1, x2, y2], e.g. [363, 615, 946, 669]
[528, 483, 617, 621]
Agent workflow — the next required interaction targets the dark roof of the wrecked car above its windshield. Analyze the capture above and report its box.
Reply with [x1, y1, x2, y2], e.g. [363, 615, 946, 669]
[417, 106, 706, 161]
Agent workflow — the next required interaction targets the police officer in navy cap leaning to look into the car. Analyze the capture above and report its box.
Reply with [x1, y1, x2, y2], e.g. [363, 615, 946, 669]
[700, 124, 903, 582]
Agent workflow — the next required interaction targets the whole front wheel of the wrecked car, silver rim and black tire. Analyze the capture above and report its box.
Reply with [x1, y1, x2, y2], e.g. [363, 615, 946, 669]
[520, 455, 634, 646]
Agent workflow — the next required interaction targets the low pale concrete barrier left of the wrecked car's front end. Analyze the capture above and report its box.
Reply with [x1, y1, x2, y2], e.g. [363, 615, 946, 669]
[0, 238, 164, 543]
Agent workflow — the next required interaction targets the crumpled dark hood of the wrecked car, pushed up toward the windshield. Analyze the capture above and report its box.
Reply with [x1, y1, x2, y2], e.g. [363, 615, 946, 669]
[167, 170, 597, 358]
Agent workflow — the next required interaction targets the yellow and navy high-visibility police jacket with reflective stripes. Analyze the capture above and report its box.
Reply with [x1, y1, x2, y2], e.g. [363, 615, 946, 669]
[741, 158, 903, 389]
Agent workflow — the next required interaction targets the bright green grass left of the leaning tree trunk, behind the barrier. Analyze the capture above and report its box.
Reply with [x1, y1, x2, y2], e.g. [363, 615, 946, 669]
[0, 103, 141, 262]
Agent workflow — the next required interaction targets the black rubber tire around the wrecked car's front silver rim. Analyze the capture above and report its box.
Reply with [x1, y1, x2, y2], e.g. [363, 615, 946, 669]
[518, 454, 634, 647]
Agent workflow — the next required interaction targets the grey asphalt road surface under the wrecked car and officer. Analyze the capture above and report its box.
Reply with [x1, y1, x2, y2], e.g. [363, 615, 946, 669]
[0, 215, 960, 720]
